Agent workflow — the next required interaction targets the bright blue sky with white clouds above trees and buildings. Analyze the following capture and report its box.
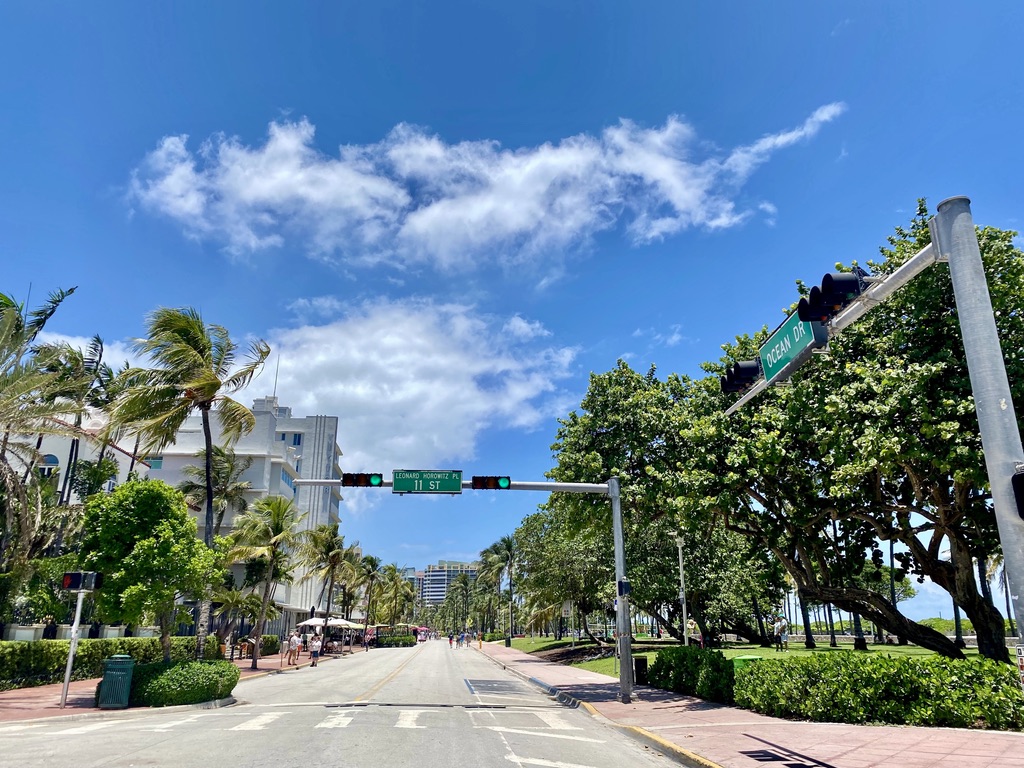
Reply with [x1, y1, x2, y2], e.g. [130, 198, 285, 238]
[0, 0, 1024, 616]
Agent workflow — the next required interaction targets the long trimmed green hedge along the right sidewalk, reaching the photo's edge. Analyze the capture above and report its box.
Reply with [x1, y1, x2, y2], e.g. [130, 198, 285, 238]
[735, 651, 1024, 730]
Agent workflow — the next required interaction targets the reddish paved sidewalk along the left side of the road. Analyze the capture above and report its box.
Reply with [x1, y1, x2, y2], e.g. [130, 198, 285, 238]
[0, 653, 340, 723]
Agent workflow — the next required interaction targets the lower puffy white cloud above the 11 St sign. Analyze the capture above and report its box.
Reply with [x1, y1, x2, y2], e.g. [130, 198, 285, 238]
[241, 300, 577, 487]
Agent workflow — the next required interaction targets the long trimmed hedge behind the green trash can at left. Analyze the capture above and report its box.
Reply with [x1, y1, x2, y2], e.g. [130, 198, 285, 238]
[0, 637, 222, 690]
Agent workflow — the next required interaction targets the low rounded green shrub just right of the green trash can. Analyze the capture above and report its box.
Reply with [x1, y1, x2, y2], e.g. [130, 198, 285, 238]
[128, 662, 241, 707]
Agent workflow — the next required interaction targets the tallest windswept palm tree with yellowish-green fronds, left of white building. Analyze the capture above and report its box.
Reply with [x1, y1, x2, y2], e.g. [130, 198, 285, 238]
[110, 307, 270, 658]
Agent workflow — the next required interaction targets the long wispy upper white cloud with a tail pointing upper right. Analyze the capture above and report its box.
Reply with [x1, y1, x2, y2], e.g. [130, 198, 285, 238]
[128, 103, 846, 269]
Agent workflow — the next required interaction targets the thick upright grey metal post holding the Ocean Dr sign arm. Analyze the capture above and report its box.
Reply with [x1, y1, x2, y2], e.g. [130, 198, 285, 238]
[928, 197, 1024, 641]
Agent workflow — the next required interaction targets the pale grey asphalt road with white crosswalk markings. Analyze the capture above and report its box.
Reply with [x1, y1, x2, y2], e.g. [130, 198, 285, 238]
[0, 640, 671, 768]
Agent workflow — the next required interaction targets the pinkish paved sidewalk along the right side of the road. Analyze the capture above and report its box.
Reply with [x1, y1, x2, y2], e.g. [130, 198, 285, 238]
[482, 643, 1024, 768]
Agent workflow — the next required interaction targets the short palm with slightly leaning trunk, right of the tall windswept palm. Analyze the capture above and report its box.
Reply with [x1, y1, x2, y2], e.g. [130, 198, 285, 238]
[231, 496, 305, 670]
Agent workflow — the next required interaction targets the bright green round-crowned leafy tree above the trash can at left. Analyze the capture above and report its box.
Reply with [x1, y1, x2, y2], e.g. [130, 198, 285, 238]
[80, 480, 217, 662]
